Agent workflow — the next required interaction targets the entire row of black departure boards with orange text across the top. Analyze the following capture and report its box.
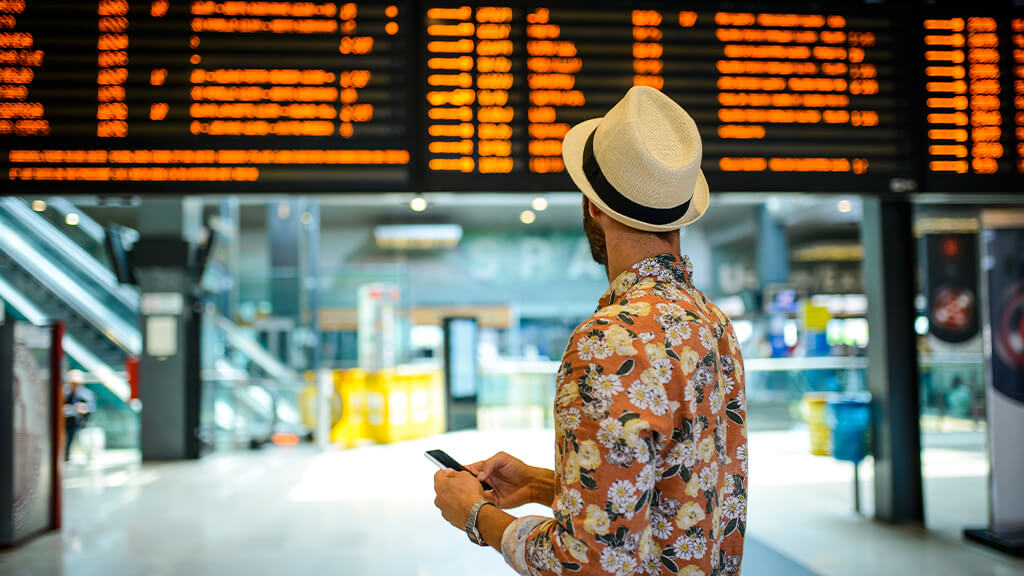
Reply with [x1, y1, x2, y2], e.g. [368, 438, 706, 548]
[0, 0, 1024, 194]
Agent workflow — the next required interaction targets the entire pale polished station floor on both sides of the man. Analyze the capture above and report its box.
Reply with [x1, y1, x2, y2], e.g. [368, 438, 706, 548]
[0, 430, 1024, 576]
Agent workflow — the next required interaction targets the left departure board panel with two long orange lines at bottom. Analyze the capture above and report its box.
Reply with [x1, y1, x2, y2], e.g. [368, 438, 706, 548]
[0, 0, 415, 193]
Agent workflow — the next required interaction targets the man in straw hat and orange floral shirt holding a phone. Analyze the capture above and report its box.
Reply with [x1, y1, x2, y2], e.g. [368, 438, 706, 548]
[434, 87, 746, 576]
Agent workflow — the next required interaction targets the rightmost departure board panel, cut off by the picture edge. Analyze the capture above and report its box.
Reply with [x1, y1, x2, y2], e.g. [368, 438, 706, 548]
[922, 4, 1024, 192]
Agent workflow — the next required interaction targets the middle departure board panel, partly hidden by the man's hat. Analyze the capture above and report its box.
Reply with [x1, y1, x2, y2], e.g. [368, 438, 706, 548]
[423, 2, 914, 192]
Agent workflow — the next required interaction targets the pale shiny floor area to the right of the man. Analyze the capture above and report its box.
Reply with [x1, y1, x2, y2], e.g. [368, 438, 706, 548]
[749, 431, 1024, 576]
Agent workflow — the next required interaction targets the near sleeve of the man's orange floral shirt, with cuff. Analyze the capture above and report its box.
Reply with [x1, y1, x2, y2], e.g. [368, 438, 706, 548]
[502, 318, 672, 576]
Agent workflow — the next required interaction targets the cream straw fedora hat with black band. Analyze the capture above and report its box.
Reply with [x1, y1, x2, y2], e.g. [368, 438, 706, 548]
[562, 86, 710, 232]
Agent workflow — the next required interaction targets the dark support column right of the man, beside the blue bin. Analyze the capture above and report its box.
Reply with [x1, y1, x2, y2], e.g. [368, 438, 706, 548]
[861, 198, 925, 524]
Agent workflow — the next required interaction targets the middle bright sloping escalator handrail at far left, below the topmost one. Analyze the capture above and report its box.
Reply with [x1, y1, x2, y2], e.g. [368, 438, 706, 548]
[0, 220, 142, 356]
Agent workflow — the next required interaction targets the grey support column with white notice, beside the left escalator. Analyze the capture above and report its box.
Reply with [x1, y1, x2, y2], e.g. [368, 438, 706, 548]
[132, 198, 202, 460]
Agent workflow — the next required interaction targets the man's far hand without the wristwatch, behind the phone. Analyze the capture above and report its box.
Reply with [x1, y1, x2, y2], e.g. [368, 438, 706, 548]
[466, 452, 554, 508]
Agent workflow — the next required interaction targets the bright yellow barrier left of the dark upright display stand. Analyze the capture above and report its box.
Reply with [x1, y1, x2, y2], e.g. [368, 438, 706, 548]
[331, 368, 444, 447]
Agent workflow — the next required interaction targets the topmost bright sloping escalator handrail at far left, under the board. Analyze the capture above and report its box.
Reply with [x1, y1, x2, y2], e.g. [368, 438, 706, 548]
[0, 198, 139, 311]
